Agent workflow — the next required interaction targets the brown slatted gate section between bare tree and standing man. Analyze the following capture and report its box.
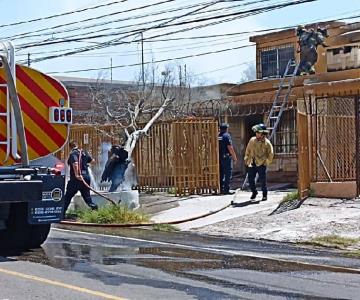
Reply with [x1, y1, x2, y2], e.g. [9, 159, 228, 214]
[134, 119, 219, 195]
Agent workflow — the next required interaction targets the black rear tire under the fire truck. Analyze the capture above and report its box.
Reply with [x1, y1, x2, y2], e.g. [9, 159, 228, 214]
[0, 203, 50, 250]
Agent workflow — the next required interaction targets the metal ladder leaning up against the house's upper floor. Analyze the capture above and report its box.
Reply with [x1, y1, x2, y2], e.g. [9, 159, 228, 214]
[241, 59, 299, 190]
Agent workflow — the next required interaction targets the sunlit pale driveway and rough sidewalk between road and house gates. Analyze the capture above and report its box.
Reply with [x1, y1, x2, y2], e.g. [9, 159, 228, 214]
[145, 191, 360, 249]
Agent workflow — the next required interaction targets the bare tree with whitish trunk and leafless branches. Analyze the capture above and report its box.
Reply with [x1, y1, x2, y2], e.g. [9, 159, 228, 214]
[91, 65, 201, 157]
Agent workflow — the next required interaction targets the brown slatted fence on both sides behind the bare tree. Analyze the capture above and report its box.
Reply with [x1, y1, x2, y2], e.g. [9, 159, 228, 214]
[57, 119, 220, 195]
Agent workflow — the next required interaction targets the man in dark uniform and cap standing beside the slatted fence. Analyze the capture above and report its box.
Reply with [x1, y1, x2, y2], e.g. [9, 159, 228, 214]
[218, 123, 237, 195]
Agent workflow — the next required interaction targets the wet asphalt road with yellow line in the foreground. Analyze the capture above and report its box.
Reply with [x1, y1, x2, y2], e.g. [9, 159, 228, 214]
[0, 229, 360, 300]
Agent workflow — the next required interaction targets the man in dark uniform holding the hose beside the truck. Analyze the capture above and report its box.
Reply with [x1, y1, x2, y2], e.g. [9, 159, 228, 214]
[64, 141, 98, 212]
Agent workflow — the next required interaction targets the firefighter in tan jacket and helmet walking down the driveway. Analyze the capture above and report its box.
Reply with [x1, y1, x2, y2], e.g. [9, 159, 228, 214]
[244, 124, 274, 201]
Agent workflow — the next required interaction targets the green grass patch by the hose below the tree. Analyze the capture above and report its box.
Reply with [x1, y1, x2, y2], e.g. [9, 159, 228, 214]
[70, 205, 150, 224]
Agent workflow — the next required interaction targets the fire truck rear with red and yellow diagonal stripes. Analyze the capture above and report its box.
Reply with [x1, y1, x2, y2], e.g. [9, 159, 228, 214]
[0, 42, 72, 249]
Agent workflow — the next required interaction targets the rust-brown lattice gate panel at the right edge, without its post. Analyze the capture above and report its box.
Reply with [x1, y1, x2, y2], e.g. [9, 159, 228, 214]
[312, 97, 356, 182]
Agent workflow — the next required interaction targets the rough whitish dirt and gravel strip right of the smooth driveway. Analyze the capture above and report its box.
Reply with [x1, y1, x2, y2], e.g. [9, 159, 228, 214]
[194, 198, 360, 249]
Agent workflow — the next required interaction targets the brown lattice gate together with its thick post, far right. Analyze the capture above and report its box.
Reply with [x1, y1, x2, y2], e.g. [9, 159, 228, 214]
[297, 96, 360, 198]
